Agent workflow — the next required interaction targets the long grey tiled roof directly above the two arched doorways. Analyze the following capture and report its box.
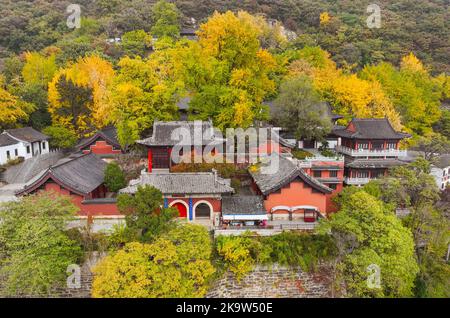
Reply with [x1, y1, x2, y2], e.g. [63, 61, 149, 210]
[120, 172, 234, 194]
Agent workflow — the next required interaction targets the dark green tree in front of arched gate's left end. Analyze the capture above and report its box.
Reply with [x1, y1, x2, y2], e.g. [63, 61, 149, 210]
[117, 186, 178, 242]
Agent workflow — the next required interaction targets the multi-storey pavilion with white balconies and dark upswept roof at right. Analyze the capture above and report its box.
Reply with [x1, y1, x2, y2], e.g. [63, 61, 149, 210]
[333, 118, 411, 185]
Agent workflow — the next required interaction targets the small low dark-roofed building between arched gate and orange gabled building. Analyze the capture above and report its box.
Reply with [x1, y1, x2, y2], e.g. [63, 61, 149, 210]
[221, 195, 268, 228]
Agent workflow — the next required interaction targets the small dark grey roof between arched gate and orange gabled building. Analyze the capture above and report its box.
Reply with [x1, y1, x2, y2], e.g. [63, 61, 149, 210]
[222, 195, 267, 215]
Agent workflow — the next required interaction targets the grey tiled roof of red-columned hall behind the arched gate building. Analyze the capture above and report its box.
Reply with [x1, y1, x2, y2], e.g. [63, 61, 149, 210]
[137, 121, 223, 146]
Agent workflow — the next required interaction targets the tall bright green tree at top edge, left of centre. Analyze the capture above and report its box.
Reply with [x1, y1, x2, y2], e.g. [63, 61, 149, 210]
[151, 0, 181, 38]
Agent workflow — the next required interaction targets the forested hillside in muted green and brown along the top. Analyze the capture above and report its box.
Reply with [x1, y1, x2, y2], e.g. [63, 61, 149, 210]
[0, 0, 450, 74]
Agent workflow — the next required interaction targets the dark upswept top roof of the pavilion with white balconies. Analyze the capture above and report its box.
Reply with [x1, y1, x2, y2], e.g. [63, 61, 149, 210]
[333, 118, 410, 139]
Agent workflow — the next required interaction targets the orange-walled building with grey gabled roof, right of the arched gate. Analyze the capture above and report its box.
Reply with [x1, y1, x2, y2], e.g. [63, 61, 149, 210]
[249, 156, 333, 222]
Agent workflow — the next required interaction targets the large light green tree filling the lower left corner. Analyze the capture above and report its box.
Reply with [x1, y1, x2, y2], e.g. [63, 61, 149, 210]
[0, 194, 81, 296]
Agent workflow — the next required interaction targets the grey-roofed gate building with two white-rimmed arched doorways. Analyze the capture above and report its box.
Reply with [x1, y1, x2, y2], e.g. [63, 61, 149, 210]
[120, 171, 234, 225]
